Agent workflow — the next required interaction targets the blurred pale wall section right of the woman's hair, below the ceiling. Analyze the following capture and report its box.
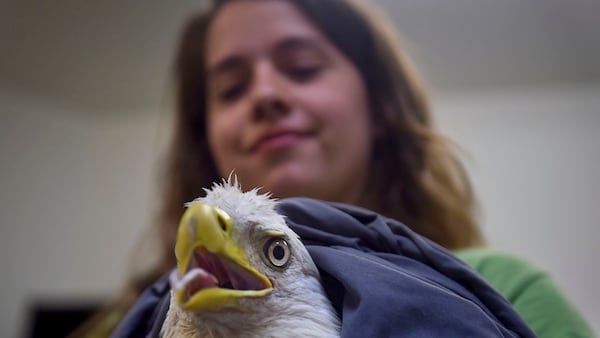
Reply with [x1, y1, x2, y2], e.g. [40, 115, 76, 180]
[434, 85, 600, 332]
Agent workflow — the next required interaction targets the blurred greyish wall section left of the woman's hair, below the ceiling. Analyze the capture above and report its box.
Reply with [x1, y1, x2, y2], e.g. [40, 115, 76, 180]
[0, 88, 166, 337]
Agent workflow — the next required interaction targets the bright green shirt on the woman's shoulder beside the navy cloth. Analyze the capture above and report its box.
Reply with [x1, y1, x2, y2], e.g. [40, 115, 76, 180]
[454, 248, 595, 338]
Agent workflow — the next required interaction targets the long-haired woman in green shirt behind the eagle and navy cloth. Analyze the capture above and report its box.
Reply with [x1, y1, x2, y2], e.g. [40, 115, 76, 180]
[72, 0, 593, 337]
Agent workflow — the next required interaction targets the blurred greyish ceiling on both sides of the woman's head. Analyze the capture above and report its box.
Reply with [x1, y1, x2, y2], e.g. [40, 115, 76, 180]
[0, 0, 600, 111]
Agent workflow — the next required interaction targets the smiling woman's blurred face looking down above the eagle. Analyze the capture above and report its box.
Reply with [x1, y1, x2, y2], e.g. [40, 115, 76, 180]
[205, 0, 372, 203]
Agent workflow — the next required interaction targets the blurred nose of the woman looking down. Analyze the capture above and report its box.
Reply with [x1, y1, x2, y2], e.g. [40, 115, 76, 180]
[252, 63, 290, 121]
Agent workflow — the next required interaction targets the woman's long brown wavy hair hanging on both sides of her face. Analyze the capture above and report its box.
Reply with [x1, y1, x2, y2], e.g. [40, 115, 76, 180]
[71, 0, 484, 336]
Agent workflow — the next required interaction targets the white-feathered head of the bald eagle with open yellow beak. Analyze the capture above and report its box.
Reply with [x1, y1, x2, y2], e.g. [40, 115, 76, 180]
[161, 179, 340, 337]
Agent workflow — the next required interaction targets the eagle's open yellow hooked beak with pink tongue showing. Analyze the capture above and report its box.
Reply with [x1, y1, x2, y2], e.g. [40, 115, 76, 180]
[173, 203, 273, 311]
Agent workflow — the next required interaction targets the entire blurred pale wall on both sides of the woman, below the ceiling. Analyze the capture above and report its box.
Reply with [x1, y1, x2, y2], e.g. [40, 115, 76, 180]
[0, 81, 600, 337]
